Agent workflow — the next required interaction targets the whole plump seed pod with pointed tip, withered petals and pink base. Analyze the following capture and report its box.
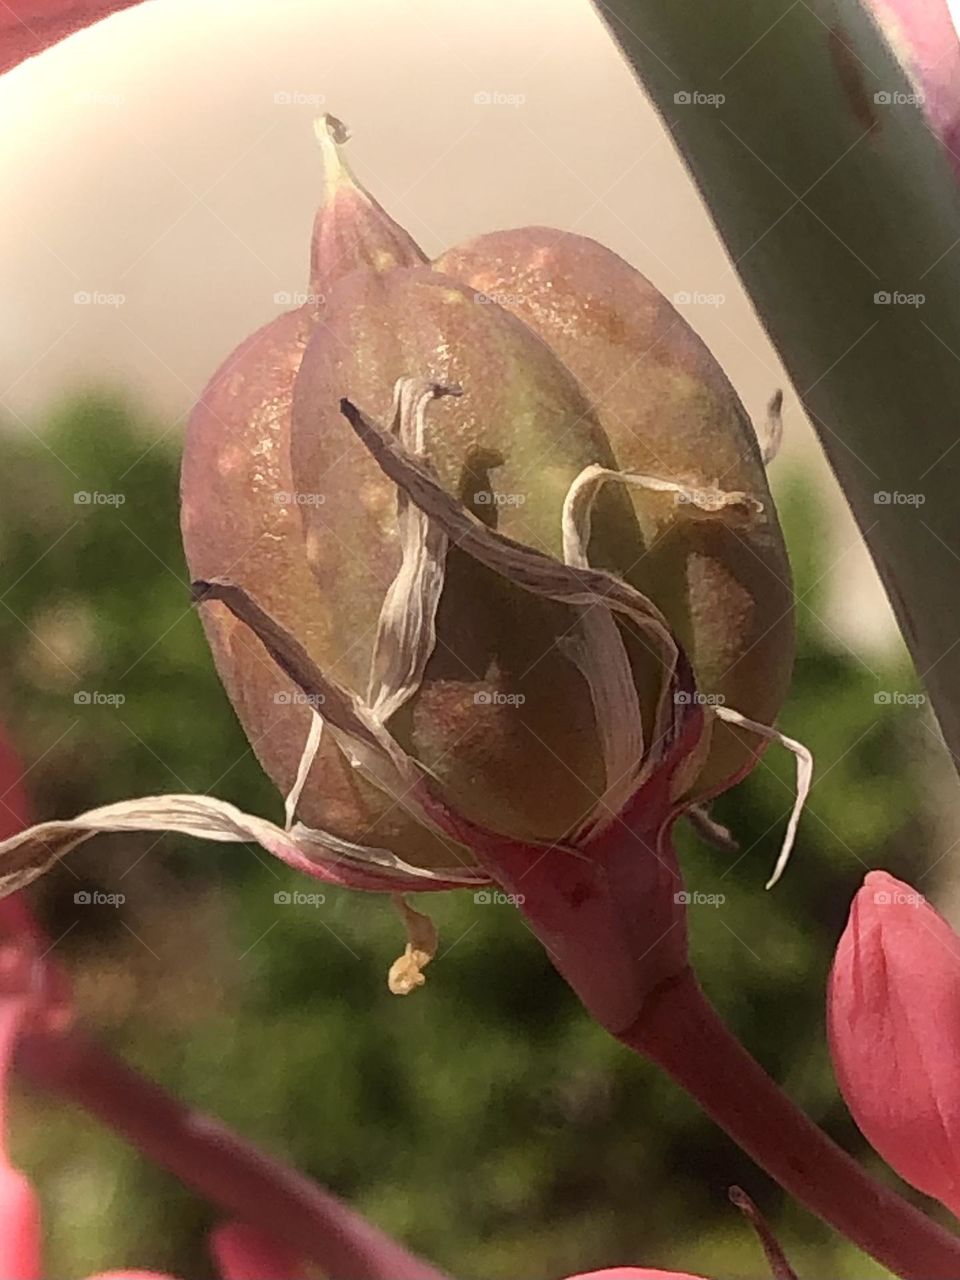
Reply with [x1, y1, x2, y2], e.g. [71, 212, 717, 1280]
[0, 116, 809, 1030]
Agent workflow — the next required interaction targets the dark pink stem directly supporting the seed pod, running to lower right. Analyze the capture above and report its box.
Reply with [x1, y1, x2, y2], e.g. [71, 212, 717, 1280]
[620, 972, 960, 1280]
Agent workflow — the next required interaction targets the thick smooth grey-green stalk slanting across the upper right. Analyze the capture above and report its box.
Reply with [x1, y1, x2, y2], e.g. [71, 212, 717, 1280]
[598, 0, 960, 759]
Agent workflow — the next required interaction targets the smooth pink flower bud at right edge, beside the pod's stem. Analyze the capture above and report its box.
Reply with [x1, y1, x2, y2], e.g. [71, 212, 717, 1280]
[827, 872, 960, 1212]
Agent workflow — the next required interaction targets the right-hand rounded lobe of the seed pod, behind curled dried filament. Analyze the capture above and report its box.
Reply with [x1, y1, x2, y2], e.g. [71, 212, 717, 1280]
[435, 227, 794, 794]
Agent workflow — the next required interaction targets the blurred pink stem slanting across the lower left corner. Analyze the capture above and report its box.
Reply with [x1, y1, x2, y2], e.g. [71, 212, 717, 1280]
[17, 1029, 447, 1280]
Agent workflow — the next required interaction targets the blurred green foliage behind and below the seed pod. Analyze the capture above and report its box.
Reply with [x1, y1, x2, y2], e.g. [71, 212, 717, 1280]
[0, 397, 947, 1280]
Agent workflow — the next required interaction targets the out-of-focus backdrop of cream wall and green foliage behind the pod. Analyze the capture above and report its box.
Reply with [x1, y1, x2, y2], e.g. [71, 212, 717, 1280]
[0, 0, 960, 1280]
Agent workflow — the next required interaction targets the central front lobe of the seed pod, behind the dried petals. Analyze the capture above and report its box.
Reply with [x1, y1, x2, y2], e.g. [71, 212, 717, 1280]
[292, 268, 663, 840]
